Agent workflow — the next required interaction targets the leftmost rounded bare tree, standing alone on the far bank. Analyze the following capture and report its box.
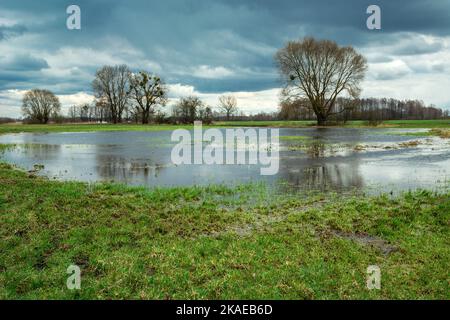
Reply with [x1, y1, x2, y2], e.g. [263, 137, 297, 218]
[22, 89, 61, 123]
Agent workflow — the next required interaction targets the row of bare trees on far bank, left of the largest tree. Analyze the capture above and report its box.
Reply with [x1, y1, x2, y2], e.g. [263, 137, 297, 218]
[22, 65, 238, 124]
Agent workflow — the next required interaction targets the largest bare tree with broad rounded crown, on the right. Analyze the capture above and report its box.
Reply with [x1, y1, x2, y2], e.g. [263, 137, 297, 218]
[275, 38, 367, 125]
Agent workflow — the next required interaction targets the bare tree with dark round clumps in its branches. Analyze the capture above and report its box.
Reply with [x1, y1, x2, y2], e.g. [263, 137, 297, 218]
[130, 71, 167, 124]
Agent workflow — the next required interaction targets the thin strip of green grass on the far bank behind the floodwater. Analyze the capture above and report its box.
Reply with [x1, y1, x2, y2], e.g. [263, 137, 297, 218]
[0, 120, 450, 134]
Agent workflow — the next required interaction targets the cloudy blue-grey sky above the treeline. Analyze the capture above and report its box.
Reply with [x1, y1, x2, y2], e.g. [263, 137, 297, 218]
[0, 0, 450, 117]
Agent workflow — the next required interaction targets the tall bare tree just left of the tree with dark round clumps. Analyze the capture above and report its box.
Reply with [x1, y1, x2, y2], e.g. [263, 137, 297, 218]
[92, 65, 131, 123]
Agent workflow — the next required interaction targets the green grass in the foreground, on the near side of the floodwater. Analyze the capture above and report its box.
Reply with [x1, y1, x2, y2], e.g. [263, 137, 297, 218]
[0, 164, 450, 299]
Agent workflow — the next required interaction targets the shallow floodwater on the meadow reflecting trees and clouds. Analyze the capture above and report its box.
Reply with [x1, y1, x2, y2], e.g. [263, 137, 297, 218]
[0, 128, 450, 192]
